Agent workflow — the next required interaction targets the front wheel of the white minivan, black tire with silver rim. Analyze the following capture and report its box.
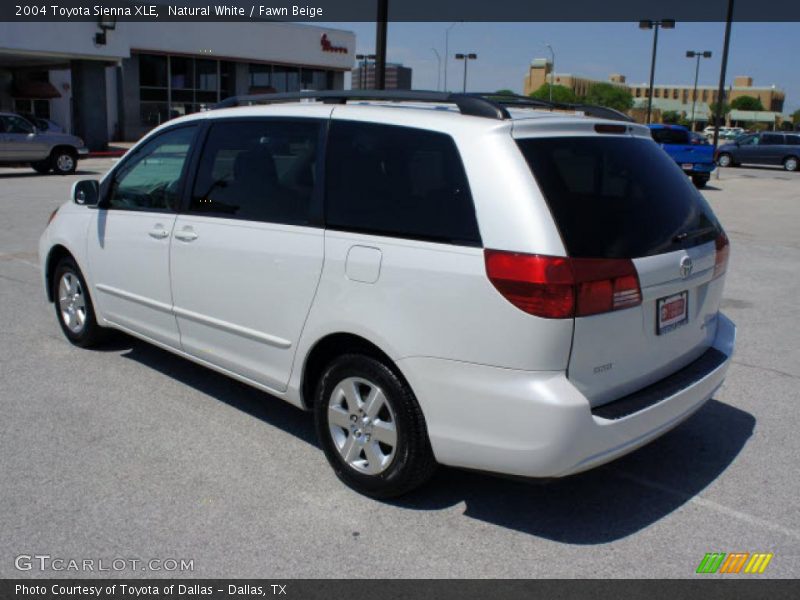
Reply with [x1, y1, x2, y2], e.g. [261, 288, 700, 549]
[52, 258, 105, 348]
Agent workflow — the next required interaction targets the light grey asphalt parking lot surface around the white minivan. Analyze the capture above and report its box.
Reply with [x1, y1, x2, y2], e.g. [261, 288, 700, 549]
[0, 159, 800, 578]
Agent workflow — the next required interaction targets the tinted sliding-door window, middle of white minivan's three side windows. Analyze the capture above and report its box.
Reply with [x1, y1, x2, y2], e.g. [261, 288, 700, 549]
[189, 120, 320, 224]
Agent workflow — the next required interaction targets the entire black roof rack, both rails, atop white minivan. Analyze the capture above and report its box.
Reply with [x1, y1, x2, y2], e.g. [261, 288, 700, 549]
[214, 90, 634, 122]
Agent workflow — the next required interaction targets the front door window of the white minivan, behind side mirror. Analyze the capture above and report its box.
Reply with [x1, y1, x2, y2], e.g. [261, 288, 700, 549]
[107, 125, 197, 211]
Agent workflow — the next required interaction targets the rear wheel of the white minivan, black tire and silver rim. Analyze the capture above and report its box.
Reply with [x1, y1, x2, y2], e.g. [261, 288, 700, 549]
[314, 354, 436, 498]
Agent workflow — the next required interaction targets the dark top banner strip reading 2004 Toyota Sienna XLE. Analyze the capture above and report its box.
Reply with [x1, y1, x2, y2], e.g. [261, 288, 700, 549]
[0, 0, 800, 22]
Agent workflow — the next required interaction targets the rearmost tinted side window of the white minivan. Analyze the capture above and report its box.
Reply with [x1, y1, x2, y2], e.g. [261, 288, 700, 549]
[325, 121, 480, 246]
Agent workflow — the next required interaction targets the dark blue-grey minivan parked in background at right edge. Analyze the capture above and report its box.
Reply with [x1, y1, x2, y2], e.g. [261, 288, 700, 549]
[716, 131, 800, 171]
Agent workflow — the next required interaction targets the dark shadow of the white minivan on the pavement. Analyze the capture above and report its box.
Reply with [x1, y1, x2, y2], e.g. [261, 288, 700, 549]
[114, 334, 756, 545]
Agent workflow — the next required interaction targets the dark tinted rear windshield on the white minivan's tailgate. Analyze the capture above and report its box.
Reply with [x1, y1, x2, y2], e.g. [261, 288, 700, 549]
[517, 136, 720, 258]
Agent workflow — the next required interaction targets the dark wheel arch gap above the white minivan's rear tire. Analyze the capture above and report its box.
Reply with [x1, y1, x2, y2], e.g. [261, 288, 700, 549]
[300, 332, 410, 409]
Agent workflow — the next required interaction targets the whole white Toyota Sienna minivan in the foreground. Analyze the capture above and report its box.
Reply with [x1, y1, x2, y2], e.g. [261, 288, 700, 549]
[40, 93, 735, 497]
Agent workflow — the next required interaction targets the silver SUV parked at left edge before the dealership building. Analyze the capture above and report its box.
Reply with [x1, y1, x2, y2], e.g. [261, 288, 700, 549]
[0, 112, 89, 175]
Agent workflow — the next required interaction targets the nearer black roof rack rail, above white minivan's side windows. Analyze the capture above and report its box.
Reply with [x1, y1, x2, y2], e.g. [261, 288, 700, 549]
[214, 90, 511, 119]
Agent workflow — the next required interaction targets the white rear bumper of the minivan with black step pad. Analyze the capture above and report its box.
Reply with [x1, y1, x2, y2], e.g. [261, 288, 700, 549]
[398, 313, 736, 477]
